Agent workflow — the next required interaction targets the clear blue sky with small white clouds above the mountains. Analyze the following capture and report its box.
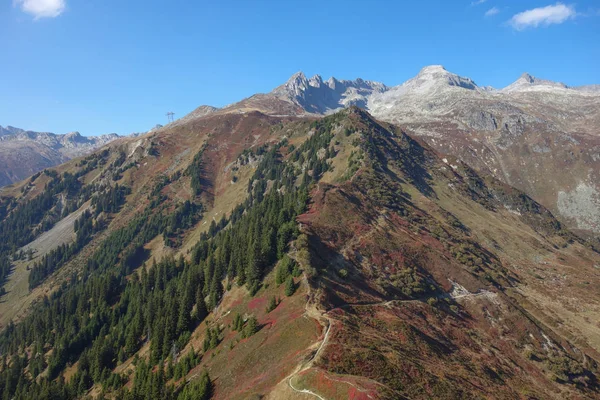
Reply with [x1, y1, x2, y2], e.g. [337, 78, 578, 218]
[0, 0, 600, 135]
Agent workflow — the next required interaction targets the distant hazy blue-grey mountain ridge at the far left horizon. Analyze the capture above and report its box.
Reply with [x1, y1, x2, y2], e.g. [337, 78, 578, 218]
[0, 126, 120, 186]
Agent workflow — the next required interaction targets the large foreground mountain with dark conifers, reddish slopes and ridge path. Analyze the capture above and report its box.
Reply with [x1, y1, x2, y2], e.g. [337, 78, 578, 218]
[0, 104, 600, 399]
